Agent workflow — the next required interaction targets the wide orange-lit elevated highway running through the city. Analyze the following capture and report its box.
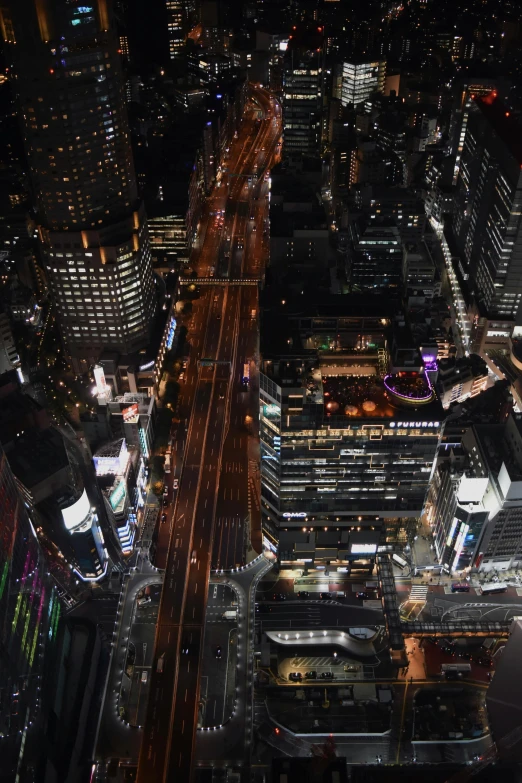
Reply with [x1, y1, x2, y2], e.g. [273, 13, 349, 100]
[134, 88, 281, 783]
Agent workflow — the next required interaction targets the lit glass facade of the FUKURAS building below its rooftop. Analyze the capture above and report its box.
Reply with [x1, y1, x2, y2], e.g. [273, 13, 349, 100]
[260, 373, 442, 535]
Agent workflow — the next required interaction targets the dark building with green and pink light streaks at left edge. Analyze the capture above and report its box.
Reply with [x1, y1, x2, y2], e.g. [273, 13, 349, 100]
[0, 440, 61, 781]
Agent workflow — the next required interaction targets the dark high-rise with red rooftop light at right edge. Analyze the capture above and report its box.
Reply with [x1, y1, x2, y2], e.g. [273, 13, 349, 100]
[455, 93, 522, 327]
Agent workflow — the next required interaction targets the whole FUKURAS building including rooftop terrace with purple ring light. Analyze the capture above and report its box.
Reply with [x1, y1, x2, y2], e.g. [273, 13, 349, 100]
[260, 304, 442, 548]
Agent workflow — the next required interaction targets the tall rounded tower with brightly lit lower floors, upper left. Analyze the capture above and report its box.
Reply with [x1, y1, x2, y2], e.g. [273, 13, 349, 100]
[0, 0, 154, 369]
